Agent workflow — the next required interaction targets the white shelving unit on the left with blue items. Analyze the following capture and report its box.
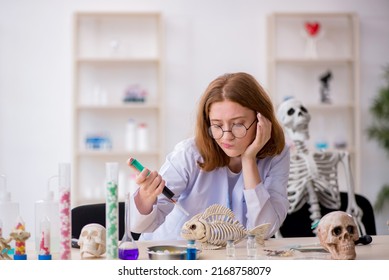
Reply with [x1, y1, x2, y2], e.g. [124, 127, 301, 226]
[72, 12, 165, 206]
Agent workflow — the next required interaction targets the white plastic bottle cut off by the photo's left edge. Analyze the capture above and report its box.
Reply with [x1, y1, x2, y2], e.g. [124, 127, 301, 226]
[0, 175, 19, 238]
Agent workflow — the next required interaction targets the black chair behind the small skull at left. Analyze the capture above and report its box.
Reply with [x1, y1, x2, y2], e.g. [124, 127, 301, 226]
[71, 202, 140, 240]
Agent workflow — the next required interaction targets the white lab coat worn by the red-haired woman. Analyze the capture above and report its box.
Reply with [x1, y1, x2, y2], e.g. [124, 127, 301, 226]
[131, 138, 290, 240]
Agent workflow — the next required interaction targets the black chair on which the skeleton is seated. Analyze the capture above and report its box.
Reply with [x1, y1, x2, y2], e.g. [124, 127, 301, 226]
[280, 192, 377, 237]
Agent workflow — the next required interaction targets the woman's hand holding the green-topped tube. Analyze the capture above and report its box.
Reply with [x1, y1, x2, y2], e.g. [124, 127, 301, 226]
[127, 158, 189, 216]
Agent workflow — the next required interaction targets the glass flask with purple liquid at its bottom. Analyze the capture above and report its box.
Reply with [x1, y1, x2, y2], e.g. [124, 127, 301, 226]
[119, 193, 139, 260]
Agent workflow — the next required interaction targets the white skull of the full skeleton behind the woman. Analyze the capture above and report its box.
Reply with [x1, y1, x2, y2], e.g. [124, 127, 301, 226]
[277, 98, 311, 141]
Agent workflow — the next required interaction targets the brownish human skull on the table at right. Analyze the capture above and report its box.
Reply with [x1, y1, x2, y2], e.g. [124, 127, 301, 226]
[317, 211, 359, 260]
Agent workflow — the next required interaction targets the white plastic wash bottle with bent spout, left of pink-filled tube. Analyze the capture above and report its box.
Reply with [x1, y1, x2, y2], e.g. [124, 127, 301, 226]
[35, 176, 60, 253]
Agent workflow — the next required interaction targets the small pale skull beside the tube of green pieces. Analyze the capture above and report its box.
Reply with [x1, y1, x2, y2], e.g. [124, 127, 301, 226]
[78, 224, 106, 258]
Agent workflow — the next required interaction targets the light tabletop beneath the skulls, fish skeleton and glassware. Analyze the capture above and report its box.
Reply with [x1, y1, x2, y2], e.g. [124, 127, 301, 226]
[22, 235, 389, 260]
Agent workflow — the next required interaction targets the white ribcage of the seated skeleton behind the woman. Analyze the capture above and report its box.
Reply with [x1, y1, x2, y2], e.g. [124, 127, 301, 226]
[288, 152, 340, 214]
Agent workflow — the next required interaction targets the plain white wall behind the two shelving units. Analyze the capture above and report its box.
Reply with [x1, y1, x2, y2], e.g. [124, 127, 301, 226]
[0, 0, 389, 240]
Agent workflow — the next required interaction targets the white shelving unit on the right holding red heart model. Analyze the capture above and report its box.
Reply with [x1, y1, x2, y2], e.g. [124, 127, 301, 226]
[267, 13, 361, 192]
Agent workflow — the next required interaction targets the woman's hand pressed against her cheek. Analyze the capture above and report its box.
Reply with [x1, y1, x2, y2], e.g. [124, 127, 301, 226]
[243, 113, 272, 158]
